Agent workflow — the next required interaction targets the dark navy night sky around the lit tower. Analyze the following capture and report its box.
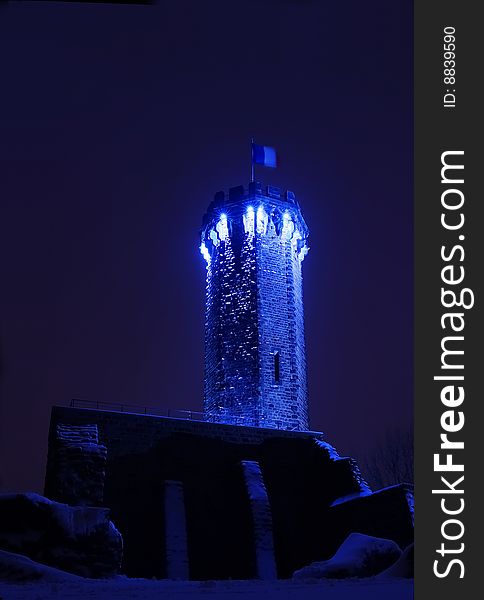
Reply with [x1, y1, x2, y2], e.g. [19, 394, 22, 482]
[0, 0, 413, 491]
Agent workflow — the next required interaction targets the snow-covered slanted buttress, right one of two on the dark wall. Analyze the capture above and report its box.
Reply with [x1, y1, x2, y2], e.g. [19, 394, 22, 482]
[241, 460, 277, 579]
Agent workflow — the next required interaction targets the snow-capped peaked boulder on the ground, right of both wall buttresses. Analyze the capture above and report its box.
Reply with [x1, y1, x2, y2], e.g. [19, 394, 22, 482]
[293, 533, 402, 579]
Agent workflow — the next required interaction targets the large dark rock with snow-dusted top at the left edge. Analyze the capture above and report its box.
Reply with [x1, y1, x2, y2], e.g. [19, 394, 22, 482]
[0, 493, 123, 577]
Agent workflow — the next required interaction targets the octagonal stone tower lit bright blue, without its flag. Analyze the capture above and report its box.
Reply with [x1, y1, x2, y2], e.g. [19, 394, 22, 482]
[200, 182, 308, 430]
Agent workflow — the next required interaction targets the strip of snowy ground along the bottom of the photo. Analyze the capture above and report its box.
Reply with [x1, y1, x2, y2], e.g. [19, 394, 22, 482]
[0, 577, 413, 600]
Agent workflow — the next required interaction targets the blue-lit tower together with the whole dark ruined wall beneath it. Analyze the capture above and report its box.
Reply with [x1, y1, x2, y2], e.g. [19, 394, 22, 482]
[39, 172, 413, 580]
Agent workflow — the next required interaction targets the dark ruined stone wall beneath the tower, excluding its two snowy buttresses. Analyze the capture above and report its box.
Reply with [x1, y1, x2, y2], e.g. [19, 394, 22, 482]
[46, 407, 413, 580]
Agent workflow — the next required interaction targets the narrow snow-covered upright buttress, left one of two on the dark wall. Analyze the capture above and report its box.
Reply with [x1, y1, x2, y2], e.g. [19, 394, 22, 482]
[164, 480, 189, 579]
